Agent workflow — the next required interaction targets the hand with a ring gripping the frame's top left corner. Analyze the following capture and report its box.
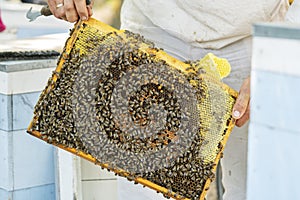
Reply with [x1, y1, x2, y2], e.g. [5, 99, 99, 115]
[48, 0, 93, 22]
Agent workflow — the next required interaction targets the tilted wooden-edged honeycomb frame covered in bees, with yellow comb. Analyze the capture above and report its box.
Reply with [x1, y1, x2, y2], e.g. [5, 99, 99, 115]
[27, 18, 237, 199]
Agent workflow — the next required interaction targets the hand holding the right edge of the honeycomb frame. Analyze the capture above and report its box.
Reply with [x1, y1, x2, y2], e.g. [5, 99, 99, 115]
[232, 77, 250, 127]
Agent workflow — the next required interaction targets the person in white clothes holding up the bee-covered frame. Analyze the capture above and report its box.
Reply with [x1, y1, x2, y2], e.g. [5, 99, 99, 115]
[48, 0, 296, 200]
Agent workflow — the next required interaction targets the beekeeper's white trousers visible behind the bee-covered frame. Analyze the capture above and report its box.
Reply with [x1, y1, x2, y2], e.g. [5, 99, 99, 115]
[118, 27, 251, 200]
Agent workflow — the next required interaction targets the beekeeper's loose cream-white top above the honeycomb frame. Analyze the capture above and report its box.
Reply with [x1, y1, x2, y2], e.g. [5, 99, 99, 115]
[121, 0, 289, 49]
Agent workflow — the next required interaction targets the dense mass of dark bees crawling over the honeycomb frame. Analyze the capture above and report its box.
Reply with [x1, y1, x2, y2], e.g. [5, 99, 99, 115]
[32, 27, 224, 199]
